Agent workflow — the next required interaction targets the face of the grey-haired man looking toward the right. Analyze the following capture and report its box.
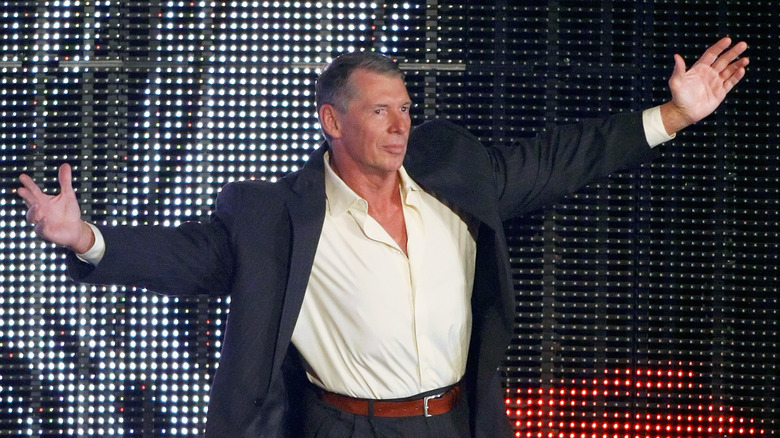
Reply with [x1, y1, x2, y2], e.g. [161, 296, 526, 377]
[331, 70, 412, 176]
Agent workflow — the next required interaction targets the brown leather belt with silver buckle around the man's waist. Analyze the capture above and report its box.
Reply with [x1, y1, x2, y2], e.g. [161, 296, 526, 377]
[320, 385, 460, 417]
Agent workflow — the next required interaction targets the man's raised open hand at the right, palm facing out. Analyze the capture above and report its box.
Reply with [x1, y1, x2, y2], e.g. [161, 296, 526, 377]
[661, 37, 749, 135]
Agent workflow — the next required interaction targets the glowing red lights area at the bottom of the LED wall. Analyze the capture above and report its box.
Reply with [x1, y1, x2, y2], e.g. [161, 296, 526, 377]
[505, 369, 769, 438]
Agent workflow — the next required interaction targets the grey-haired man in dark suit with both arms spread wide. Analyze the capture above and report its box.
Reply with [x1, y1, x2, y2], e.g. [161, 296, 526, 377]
[19, 38, 748, 437]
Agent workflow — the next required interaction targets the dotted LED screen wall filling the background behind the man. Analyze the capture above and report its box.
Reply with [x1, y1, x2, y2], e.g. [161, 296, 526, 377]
[0, 0, 780, 437]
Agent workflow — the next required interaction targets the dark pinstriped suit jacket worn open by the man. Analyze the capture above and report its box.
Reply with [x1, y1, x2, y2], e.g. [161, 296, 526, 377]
[69, 114, 654, 438]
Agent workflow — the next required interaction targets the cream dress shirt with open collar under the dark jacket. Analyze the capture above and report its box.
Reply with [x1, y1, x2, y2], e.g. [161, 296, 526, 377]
[292, 153, 476, 399]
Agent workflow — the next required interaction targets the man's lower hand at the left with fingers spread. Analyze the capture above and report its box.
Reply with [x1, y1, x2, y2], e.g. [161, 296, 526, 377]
[17, 164, 95, 254]
